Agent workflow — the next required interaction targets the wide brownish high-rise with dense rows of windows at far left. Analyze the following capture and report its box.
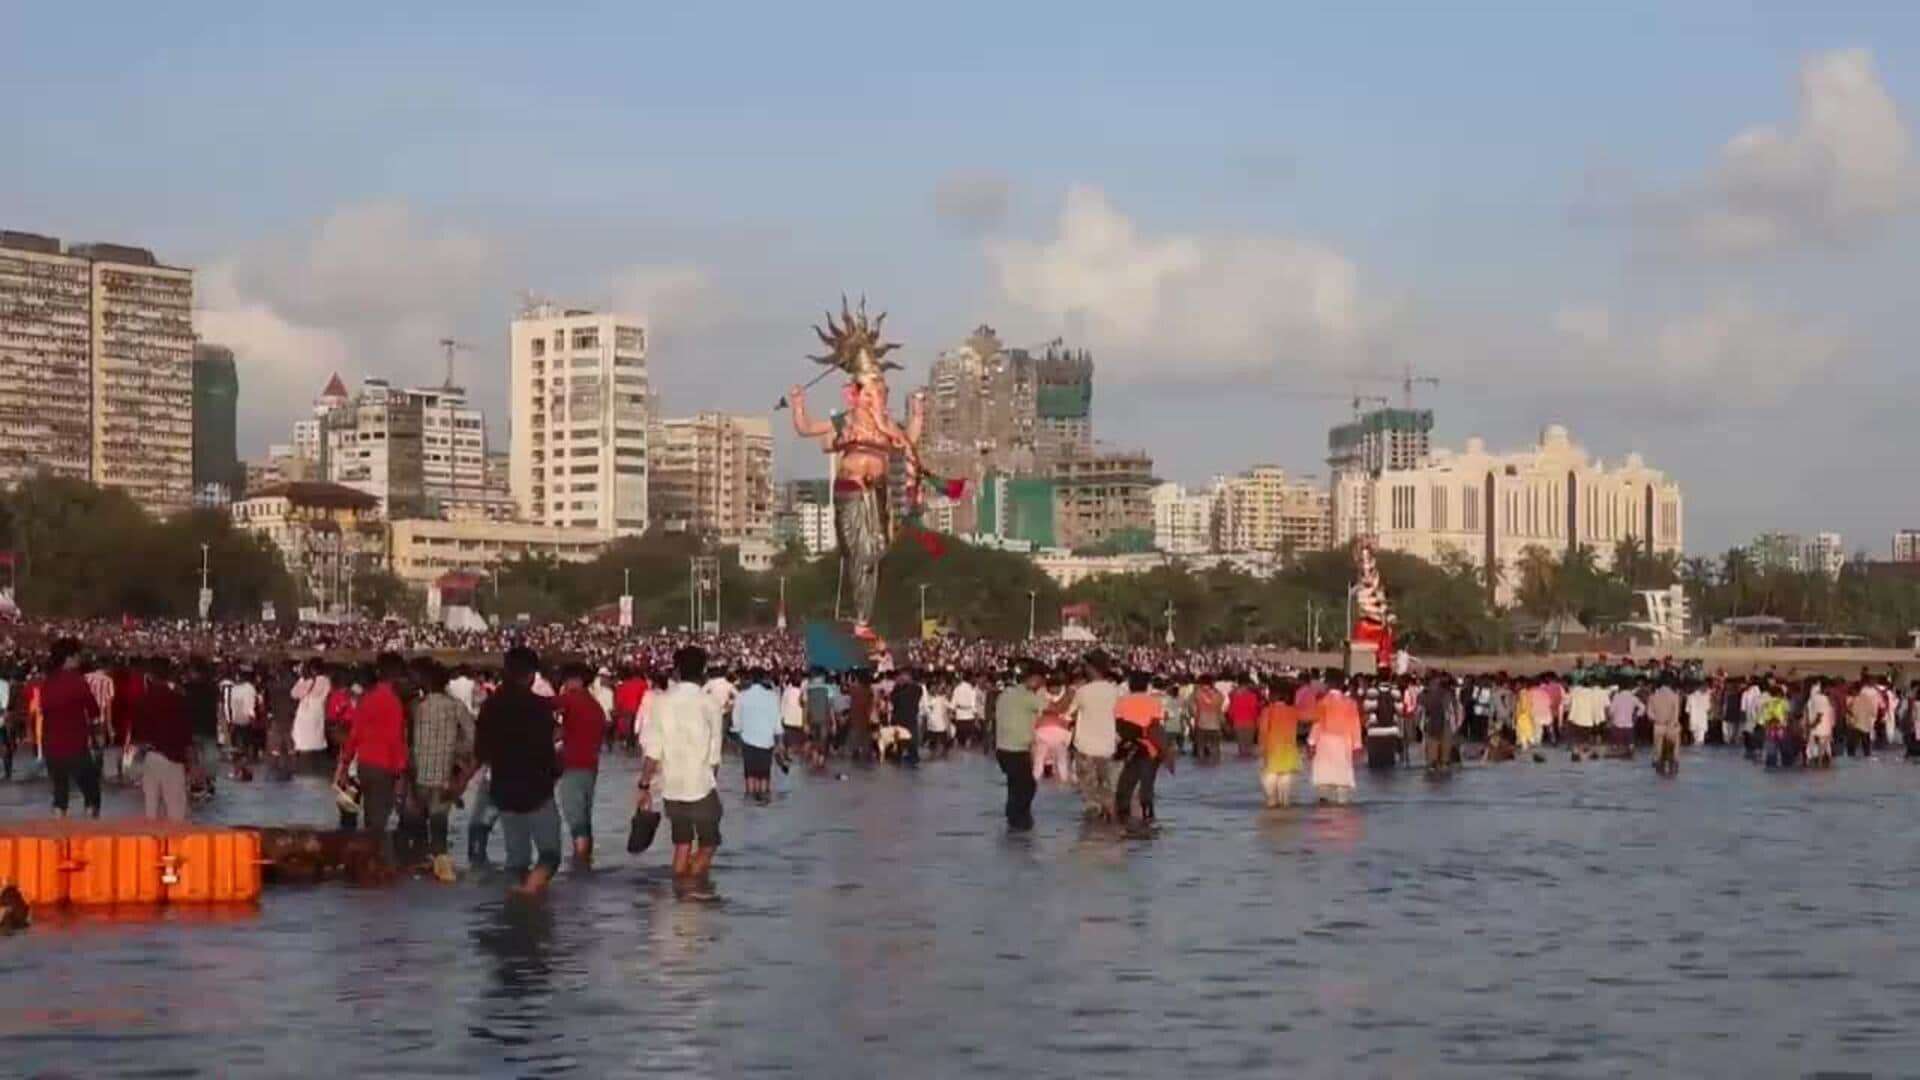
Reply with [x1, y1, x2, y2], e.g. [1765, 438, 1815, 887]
[0, 233, 194, 513]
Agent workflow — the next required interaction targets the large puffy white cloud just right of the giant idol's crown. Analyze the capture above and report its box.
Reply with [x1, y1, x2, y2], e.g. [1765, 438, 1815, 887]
[987, 186, 1380, 379]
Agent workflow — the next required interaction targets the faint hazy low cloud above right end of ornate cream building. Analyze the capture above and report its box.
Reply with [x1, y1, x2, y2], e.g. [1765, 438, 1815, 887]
[1553, 294, 1847, 407]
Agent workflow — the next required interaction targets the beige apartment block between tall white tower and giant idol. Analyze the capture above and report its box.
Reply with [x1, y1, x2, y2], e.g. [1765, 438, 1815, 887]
[647, 413, 774, 542]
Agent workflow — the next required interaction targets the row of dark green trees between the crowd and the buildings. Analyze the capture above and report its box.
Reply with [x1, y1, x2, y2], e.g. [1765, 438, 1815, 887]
[0, 475, 1920, 655]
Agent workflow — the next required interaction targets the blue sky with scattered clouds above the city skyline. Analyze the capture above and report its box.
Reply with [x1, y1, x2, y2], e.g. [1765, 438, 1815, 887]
[0, 0, 1920, 553]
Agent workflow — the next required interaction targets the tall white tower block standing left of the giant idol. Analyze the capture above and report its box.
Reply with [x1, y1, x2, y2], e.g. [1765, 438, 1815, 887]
[509, 304, 651, 536]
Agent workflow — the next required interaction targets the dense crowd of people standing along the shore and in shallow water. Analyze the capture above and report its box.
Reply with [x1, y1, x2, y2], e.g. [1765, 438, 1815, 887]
[0, 614, 1920, 896]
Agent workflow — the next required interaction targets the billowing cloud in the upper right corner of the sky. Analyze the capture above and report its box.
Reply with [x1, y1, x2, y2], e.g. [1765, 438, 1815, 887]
[1634, 48, 1920, 256]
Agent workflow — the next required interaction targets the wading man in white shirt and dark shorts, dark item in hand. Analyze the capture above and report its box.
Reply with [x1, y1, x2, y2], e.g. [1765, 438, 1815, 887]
[639, 646, 724, 899]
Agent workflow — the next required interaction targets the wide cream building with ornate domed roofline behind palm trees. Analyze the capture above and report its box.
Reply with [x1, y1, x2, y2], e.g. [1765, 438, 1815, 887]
[1369, 425, 1686, 603]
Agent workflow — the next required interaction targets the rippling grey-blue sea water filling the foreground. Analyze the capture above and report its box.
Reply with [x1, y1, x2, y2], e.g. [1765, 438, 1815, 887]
[0, 753, 1920, 1078]
